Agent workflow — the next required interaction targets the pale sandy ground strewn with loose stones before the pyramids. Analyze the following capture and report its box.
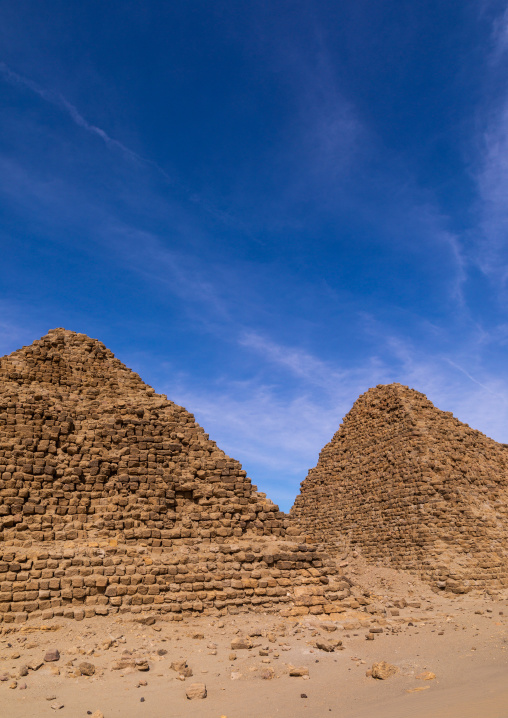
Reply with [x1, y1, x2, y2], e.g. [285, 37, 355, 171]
[0, 566, 508, 718]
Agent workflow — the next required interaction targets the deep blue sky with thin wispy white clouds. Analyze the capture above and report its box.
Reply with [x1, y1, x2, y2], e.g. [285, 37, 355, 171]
[0, 0, 508, 509]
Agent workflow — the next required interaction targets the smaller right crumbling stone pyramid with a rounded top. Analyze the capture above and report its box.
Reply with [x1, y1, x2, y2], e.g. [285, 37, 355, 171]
[290, 384, 508, 593]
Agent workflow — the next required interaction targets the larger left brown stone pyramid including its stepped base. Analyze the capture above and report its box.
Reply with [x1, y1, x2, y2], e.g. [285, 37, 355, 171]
[0, 329, 349, 621]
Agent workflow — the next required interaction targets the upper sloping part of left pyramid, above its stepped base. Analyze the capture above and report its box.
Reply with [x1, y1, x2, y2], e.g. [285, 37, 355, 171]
[0, 329, 284, 546]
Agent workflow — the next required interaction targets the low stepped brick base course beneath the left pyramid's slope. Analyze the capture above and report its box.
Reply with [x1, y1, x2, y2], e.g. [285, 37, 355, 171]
[0, 540, 351, 623]
